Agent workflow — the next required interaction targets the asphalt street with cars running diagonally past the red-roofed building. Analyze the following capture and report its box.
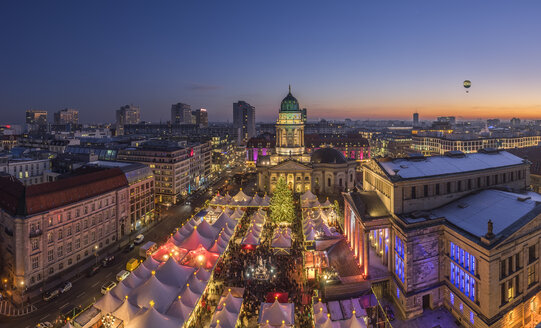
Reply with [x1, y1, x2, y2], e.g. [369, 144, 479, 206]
[0, 169, 244, 328]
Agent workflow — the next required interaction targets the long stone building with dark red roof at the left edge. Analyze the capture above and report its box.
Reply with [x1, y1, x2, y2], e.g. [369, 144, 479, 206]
[0, 169, 129, 301]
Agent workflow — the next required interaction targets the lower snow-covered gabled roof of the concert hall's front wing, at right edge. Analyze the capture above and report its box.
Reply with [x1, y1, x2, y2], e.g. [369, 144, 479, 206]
[430, 189, 541, 237]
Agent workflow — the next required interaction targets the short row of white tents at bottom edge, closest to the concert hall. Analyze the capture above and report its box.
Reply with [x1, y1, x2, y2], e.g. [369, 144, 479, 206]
[313, 299, 367, 328]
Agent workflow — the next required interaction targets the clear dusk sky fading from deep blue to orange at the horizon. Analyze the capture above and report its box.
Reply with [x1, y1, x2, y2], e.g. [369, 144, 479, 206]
[0, 0, 541, 123]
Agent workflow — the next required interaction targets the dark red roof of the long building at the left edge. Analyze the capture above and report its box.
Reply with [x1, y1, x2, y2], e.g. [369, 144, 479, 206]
[0, 168, 128, 215]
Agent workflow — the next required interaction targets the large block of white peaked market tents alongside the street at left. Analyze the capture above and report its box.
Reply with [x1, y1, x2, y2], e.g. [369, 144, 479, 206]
[86, 211, 244, 328]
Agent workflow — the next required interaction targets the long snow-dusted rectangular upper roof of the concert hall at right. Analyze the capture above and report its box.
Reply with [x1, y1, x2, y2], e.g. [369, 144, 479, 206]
[378, 151, 524, 179]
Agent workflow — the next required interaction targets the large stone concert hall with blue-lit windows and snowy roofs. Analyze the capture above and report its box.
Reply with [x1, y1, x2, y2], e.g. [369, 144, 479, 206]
[343, 151, 541, 327]
